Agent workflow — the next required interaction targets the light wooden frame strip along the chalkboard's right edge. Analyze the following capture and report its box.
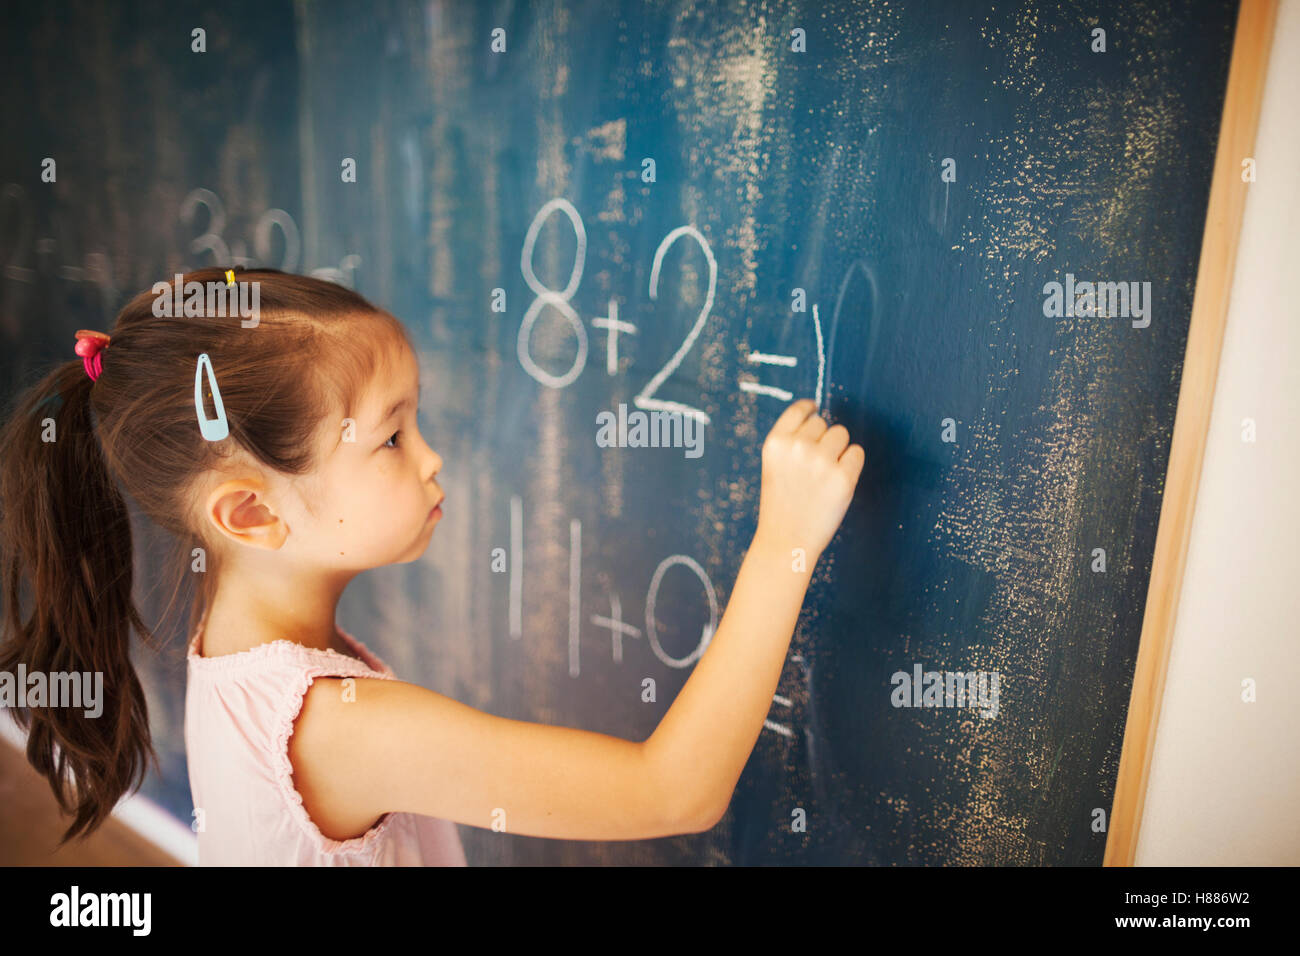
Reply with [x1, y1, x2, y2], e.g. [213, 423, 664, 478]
[1102, 0, 1277, 866]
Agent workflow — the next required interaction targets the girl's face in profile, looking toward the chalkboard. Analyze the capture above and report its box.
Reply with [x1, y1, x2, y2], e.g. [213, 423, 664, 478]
[283, 345, 443, 571]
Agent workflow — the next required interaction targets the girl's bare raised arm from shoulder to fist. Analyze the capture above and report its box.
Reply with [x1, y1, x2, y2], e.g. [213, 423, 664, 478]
[290, 399, 865, 840]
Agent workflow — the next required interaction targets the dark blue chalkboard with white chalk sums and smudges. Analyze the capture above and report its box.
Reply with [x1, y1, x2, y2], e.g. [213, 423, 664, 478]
[0, 1, 1236, 865]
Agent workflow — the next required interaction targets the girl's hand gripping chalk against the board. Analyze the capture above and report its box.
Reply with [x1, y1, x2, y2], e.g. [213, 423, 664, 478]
[754, 398, 867, 567]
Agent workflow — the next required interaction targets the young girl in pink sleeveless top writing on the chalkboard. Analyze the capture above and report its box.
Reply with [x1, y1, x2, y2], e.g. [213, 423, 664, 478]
[0, 269, 863, 865]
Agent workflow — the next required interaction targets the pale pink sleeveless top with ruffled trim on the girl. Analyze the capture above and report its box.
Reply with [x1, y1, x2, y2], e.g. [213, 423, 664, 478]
[185, 613, 465, 866]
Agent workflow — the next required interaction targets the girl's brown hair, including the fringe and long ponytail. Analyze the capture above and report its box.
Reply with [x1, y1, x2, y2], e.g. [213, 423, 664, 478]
[0, 268, 410, 845]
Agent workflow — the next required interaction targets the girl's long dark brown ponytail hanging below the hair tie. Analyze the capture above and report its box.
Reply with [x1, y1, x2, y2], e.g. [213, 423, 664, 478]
[0, 355, 157, 845]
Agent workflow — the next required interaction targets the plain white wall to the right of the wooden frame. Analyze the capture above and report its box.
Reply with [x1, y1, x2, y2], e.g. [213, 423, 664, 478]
[1136, 0, 1300, 866]
